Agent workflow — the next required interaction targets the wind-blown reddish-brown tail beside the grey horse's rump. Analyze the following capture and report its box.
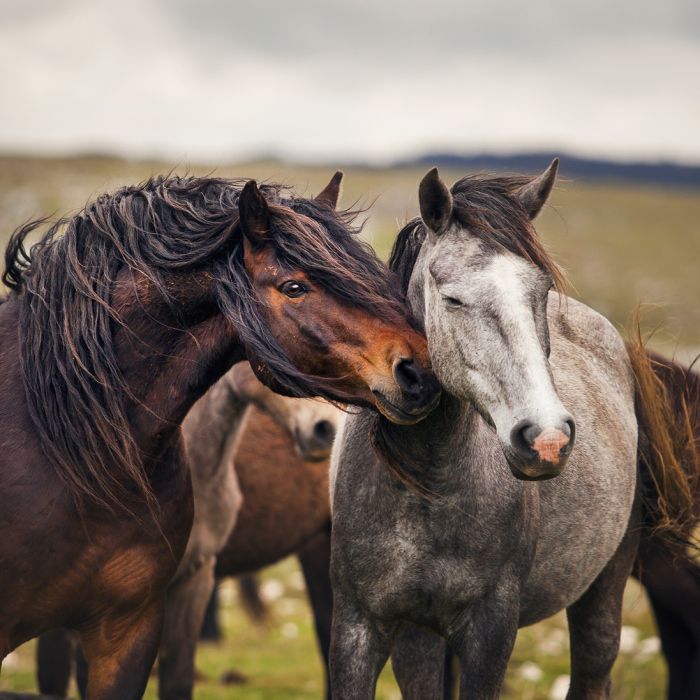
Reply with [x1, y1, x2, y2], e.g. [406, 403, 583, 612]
[627, 323, 700, 546]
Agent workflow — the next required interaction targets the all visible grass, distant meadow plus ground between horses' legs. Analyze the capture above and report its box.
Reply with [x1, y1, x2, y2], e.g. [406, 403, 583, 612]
[0, 158, 700, 700]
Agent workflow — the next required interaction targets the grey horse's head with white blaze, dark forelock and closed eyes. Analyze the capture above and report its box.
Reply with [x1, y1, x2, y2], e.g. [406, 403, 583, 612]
[408, 160, 575, 479]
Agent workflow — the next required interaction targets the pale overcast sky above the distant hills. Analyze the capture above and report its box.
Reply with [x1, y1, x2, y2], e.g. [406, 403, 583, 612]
[0, 0, 700, 163]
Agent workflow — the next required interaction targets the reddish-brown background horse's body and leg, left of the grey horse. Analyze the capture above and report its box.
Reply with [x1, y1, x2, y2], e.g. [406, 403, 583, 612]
[214, 408, 333, 695]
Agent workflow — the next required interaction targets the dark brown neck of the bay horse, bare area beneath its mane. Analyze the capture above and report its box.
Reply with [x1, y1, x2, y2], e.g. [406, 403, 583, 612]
[115, 270, 245, 457]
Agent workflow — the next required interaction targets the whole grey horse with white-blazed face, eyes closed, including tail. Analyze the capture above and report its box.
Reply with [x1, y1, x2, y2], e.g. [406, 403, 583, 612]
[330, 161, 697, 700]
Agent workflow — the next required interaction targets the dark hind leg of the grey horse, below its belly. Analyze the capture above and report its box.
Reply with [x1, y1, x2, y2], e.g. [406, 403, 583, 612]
[566, 517, 639, 700]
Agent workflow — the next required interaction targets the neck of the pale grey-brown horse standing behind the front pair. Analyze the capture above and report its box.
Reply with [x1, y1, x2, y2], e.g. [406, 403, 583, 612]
[182, 371, 250, 486]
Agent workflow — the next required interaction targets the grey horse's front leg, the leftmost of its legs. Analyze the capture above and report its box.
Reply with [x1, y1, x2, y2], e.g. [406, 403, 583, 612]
[330, 590, 391, 700]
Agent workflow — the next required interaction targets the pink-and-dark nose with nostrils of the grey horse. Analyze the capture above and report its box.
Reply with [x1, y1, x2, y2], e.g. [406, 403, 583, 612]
[510, 416, 576, 473]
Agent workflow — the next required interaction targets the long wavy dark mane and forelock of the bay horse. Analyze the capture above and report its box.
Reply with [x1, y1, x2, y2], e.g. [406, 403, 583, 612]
[3, 176, 403, 510]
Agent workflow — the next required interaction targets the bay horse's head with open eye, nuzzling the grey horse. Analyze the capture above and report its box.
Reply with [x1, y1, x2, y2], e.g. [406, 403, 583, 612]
[224, 173, 439, 424]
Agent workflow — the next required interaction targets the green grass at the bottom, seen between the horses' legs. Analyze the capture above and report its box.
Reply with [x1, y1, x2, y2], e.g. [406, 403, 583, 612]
[0, 559, 665, 700]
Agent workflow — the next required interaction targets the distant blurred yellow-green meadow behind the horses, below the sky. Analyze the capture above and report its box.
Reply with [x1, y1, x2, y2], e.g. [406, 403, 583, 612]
[0, 157, 700, 359]
